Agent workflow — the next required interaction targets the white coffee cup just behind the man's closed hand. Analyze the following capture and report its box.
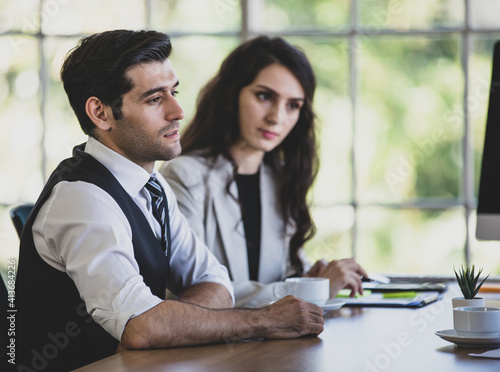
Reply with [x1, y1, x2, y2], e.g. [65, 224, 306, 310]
[274, 277, 330, 306]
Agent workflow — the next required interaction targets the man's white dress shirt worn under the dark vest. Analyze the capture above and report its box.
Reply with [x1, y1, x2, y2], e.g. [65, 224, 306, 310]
[33, 137, 234, 340]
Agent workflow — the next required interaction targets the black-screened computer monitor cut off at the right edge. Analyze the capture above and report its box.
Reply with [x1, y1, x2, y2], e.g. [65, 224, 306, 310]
[476, 41, 500, 240]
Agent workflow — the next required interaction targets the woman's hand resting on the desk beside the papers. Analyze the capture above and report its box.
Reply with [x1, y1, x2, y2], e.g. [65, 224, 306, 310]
[304, 258, 368, 298]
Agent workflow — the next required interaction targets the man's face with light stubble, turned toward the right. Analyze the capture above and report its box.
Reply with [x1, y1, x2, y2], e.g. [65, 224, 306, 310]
[101, 59, 184, 172]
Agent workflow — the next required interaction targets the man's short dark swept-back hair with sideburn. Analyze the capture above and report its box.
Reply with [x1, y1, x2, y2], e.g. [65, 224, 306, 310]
[61, 30, 172, 135]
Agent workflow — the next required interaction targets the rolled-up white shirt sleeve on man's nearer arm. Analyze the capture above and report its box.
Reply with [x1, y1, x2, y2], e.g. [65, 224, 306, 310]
[33, 182, 162, 340]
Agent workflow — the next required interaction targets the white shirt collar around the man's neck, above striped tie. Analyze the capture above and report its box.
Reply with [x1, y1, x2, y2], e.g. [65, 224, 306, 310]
[85, 137, 151, 197]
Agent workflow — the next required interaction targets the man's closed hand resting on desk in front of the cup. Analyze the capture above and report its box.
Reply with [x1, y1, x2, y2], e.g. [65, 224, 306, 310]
[262, 296, 325, 339]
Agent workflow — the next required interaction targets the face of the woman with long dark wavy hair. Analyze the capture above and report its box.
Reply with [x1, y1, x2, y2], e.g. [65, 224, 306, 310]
[236, 63, 304, 153]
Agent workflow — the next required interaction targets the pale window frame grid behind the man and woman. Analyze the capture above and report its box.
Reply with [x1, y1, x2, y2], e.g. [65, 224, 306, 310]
[0, 0, 500, 263]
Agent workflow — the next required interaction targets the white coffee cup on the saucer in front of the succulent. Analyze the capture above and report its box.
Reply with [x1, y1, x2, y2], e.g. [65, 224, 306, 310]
[453, 306, 500, 337]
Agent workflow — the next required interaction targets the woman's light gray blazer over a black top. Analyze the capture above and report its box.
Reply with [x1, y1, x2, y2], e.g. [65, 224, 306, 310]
[160, 155, 293, 307]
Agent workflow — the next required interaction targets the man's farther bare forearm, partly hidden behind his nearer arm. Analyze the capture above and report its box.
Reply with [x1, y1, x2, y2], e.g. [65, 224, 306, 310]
[177, 282, 233, 309]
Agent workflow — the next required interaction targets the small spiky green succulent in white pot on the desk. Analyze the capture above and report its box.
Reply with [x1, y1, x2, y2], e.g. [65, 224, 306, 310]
[451, 265, 489, 307]
